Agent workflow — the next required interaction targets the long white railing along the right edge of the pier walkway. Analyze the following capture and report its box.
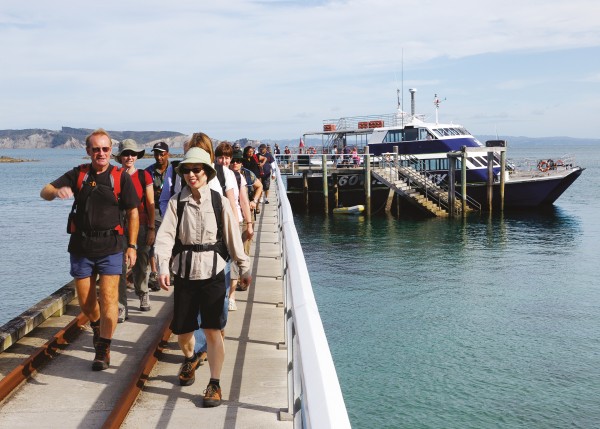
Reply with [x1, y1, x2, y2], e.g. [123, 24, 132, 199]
[274, 162, 350, 429]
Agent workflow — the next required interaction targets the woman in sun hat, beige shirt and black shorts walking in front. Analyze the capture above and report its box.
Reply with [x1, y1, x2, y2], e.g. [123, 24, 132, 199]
[155, 147, 252, 407]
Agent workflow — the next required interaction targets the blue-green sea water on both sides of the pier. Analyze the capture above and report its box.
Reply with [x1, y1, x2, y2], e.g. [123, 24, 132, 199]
[0, 146, 600, 429]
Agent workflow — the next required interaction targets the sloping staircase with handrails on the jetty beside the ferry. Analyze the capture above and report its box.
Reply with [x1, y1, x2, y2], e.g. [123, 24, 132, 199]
[371, 158, 473, 217]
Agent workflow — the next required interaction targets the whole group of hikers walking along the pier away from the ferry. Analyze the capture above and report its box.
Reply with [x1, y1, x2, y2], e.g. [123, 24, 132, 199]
[40, 129, 280, 407]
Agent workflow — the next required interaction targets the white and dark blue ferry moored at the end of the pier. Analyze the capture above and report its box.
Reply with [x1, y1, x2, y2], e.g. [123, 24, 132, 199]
[288, 89, 584, 209]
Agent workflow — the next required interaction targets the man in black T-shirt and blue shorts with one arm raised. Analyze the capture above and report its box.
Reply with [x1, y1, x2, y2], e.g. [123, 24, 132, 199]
[40, 128, 140, 371]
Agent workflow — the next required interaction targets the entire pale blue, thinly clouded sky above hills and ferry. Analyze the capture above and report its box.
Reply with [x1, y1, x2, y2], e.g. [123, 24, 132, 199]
[0, 0, 600, 140]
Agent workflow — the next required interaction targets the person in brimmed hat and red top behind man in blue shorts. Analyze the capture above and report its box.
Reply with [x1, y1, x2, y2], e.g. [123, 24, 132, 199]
[114, 139, 156, 323]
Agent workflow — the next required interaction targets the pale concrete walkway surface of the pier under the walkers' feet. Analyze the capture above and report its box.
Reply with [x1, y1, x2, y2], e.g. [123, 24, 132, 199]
[0, 186, 293, 429]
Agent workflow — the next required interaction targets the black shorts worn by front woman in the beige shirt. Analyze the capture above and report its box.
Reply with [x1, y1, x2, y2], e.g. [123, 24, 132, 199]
[171, 271, 225, 335]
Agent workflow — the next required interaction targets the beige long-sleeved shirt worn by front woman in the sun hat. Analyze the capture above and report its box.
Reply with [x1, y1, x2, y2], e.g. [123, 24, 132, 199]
[154, 185, 250, 280]
